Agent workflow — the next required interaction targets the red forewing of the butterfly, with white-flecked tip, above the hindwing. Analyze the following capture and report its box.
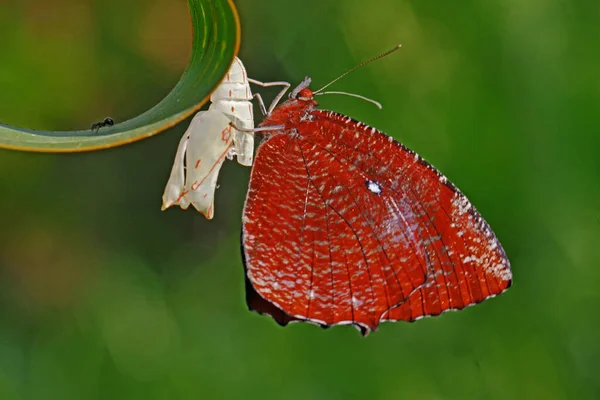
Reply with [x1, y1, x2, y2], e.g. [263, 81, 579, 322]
[301, 111, 511, 320]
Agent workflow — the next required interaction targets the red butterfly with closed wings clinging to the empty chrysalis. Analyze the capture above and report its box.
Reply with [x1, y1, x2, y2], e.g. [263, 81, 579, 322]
[242, 45, 512, 335]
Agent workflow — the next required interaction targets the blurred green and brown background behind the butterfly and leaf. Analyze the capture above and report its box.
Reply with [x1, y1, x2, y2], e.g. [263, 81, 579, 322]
[0, 0, 600, 400]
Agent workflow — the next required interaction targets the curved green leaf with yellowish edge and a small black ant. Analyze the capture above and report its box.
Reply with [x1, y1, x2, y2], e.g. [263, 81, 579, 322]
[0, 0, 240, 153]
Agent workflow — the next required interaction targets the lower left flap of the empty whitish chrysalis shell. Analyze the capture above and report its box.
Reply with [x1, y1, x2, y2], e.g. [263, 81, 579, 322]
[163, 109, 233, 219]
